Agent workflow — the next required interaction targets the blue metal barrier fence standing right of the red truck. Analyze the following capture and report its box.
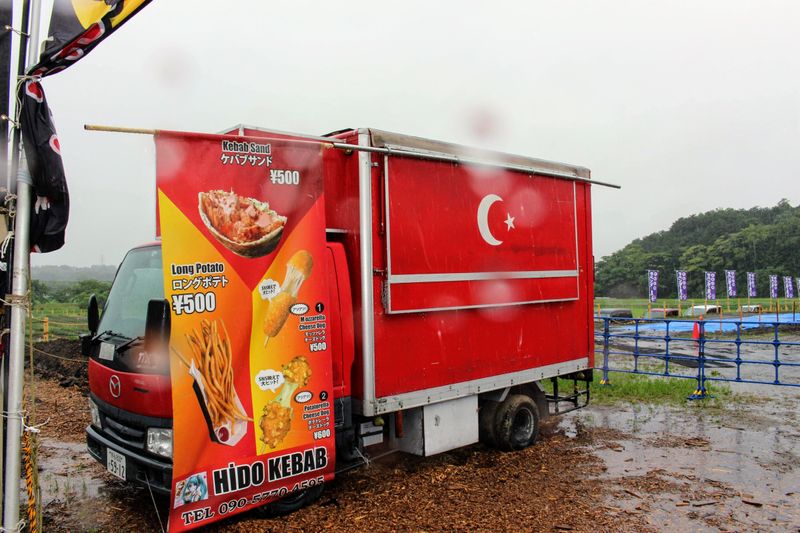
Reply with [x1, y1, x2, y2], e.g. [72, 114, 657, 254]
[595, 313, 800, 399]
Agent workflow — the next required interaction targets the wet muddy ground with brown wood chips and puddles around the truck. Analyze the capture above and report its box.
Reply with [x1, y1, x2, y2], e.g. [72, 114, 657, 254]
[25, 343, 800, 532]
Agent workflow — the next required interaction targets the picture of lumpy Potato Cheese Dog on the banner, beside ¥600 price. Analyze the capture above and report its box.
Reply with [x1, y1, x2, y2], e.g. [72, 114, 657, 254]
[258, 355, 311, 454]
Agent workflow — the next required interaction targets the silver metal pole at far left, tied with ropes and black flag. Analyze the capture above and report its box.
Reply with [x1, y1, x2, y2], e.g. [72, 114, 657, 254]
[3, 0, 42, 531]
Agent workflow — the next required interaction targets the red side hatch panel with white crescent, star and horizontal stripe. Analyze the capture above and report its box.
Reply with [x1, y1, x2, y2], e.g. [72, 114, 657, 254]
[384, 157, 578, 313]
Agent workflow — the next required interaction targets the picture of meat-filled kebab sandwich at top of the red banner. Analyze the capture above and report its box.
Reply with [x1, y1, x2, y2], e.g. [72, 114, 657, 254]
[197, 190, 286, 257]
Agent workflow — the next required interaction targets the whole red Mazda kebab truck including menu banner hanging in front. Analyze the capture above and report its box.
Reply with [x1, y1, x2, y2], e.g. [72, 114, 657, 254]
[83, 126, 596, 529]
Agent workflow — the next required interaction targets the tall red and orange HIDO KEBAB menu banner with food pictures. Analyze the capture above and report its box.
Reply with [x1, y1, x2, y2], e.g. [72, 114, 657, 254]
[156, 132, 334, 531]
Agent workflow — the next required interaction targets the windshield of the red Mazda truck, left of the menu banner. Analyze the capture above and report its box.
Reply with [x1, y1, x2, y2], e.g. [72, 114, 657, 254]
[98, 246, 164, 339]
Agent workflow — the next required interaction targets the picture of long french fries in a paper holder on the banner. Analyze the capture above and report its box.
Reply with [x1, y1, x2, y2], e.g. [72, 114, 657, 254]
[173, 320, 252, 446]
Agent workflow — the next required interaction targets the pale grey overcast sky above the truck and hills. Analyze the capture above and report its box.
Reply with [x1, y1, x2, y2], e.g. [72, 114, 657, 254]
[15, 0, 800, 265]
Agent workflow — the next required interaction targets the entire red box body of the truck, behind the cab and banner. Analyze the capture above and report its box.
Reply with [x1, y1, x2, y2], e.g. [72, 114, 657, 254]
[220, 127, 594, 414]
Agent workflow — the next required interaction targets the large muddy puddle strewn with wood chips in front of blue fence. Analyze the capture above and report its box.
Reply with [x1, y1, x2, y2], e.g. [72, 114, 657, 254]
[557, 401, 800, 531]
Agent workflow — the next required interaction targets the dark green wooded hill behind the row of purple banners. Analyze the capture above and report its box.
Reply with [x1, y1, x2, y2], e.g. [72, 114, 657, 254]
[595, 199, 800, 298]
